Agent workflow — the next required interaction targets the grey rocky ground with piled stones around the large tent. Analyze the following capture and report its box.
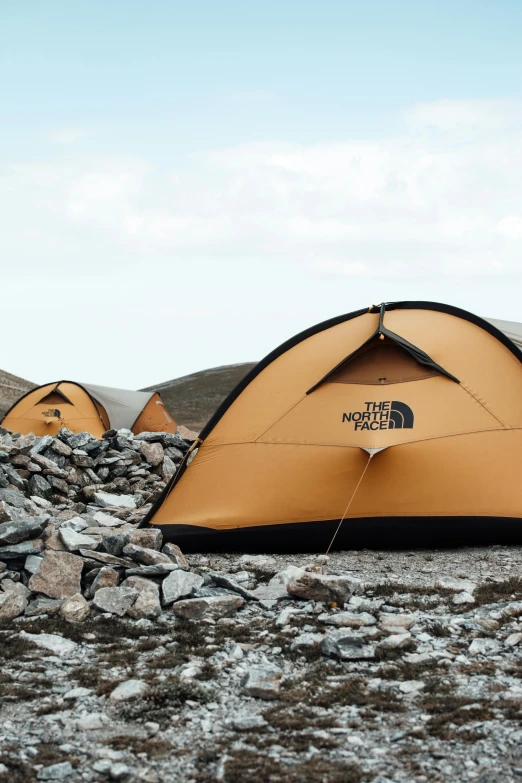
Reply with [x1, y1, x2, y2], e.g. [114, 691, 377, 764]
[0, 431, 522, 783]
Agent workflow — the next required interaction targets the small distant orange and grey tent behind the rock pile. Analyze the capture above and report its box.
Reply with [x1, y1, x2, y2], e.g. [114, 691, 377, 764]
[0, 381, 177, 438]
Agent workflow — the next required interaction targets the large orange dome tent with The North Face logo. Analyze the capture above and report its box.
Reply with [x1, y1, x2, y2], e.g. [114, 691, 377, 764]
[145, 302, 522, 551]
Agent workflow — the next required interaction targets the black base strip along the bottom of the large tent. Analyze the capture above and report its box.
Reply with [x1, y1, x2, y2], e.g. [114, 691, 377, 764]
[151, 517, 522, 554]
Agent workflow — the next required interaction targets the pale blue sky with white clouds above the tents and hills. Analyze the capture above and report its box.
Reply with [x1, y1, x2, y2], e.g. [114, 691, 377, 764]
[0, 0, 522, 388]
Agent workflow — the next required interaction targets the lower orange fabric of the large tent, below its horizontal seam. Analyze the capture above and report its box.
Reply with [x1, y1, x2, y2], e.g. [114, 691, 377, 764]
[152, 430, 522, 532]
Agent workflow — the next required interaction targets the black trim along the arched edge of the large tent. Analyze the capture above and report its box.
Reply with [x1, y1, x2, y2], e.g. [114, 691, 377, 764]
[140, 301, 522, 524]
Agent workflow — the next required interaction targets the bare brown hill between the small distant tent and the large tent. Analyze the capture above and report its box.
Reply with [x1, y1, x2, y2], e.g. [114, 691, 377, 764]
[142, 362, 256, 432]
